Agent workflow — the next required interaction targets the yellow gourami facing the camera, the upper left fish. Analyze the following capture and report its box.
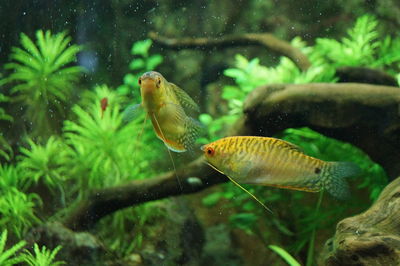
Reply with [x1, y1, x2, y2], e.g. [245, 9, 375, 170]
[125, 71, 201, 152]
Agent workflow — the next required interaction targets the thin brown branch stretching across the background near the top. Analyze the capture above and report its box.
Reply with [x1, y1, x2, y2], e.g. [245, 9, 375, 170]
[149, 32, 311, 71]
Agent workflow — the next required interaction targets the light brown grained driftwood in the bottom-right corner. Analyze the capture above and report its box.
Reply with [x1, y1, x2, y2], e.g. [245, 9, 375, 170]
[320, 177, 400, 266]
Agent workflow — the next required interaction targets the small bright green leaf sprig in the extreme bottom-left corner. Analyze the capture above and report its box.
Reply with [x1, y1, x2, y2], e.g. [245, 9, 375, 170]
[0, 229, 26, 266]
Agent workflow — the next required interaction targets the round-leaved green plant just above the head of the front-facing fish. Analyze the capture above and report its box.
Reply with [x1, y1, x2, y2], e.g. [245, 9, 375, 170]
[117, 39, 164, 95]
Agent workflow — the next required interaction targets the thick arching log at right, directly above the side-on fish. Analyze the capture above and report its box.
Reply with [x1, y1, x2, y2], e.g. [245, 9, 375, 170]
[243, 83, 400, 178]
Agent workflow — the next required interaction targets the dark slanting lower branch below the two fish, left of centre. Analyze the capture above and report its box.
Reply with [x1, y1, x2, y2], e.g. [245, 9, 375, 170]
[63, 158, 228, 231]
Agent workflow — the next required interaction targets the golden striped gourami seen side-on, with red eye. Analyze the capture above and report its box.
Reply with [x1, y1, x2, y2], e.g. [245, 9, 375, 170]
[201, 136, 360, 210]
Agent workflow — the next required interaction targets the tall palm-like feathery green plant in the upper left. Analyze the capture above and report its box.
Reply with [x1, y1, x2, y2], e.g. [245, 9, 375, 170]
[1, 30, 83, 136]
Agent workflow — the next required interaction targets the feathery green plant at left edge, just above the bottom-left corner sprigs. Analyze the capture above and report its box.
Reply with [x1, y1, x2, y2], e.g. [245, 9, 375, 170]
[0, 187, 42, 238]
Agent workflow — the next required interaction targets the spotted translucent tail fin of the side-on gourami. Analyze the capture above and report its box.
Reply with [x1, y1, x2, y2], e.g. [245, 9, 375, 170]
[322, 162, 361, 200]
